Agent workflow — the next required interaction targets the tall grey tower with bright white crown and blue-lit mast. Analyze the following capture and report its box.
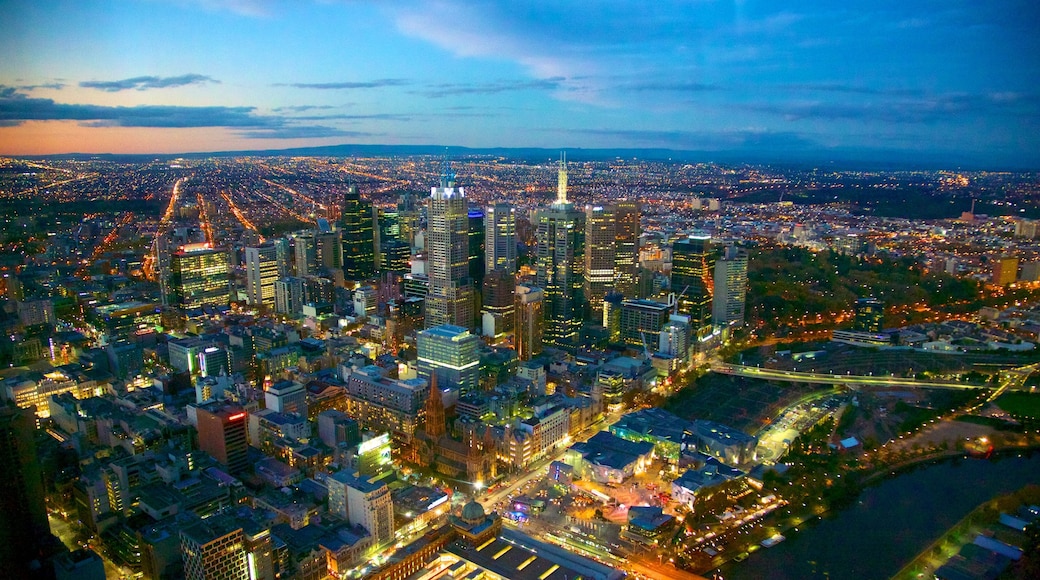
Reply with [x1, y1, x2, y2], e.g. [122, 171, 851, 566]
[425, 167, 473, 328]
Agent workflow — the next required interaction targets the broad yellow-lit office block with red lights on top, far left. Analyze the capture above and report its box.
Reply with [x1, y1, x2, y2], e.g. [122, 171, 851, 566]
[162, 243, 231, 308]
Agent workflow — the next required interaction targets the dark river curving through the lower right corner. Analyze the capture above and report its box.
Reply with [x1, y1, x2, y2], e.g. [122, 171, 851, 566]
[721, 453, 1040, 580]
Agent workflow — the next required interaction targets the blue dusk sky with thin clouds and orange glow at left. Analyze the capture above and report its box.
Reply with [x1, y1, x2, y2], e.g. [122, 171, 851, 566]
[0, 0, 1040, 169]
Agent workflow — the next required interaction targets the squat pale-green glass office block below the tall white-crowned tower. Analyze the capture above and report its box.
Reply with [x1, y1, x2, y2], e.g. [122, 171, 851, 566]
[416, 324, 480, 394]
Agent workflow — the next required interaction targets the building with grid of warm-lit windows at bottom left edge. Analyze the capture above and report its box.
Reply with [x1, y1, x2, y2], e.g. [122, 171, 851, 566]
[181, 515, 275, 580]
